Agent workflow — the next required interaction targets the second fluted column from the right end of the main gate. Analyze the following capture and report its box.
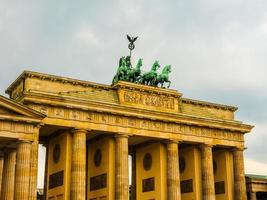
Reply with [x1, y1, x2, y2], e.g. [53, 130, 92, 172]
[201, 144, 215, 200]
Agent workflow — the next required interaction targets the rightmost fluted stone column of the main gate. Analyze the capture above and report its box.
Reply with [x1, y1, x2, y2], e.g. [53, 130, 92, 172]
[233, 148, 247, 200]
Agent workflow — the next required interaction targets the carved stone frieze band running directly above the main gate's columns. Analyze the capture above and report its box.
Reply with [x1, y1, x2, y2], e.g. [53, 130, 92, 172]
[31, 104, 244, 142]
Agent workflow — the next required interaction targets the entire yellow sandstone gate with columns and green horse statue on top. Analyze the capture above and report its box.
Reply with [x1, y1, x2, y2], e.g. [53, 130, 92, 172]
[0, 37, 253, 200]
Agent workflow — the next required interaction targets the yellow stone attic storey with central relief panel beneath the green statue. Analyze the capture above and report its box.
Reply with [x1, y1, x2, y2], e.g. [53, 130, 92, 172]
[6, 71, 241, 120]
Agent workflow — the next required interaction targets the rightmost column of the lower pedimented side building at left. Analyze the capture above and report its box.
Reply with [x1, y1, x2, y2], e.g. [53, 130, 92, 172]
[14, 141, 31, 200]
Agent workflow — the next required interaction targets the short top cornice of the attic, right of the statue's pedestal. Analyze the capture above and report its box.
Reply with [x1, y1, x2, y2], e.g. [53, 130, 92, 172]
[181, 98, 238, 112]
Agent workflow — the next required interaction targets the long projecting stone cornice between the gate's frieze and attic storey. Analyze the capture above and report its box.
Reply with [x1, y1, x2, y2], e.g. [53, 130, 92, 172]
[19, 91, 253, 133]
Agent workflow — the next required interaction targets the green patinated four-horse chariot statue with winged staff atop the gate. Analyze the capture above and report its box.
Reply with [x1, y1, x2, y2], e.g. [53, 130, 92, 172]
[112, 35, 171, 88]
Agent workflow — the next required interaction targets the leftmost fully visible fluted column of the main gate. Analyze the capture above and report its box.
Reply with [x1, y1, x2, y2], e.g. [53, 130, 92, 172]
[70, 129, 87, 200]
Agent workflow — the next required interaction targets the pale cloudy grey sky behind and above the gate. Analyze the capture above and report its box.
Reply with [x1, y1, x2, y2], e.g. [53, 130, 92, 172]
[0, 0, 267, 188]
